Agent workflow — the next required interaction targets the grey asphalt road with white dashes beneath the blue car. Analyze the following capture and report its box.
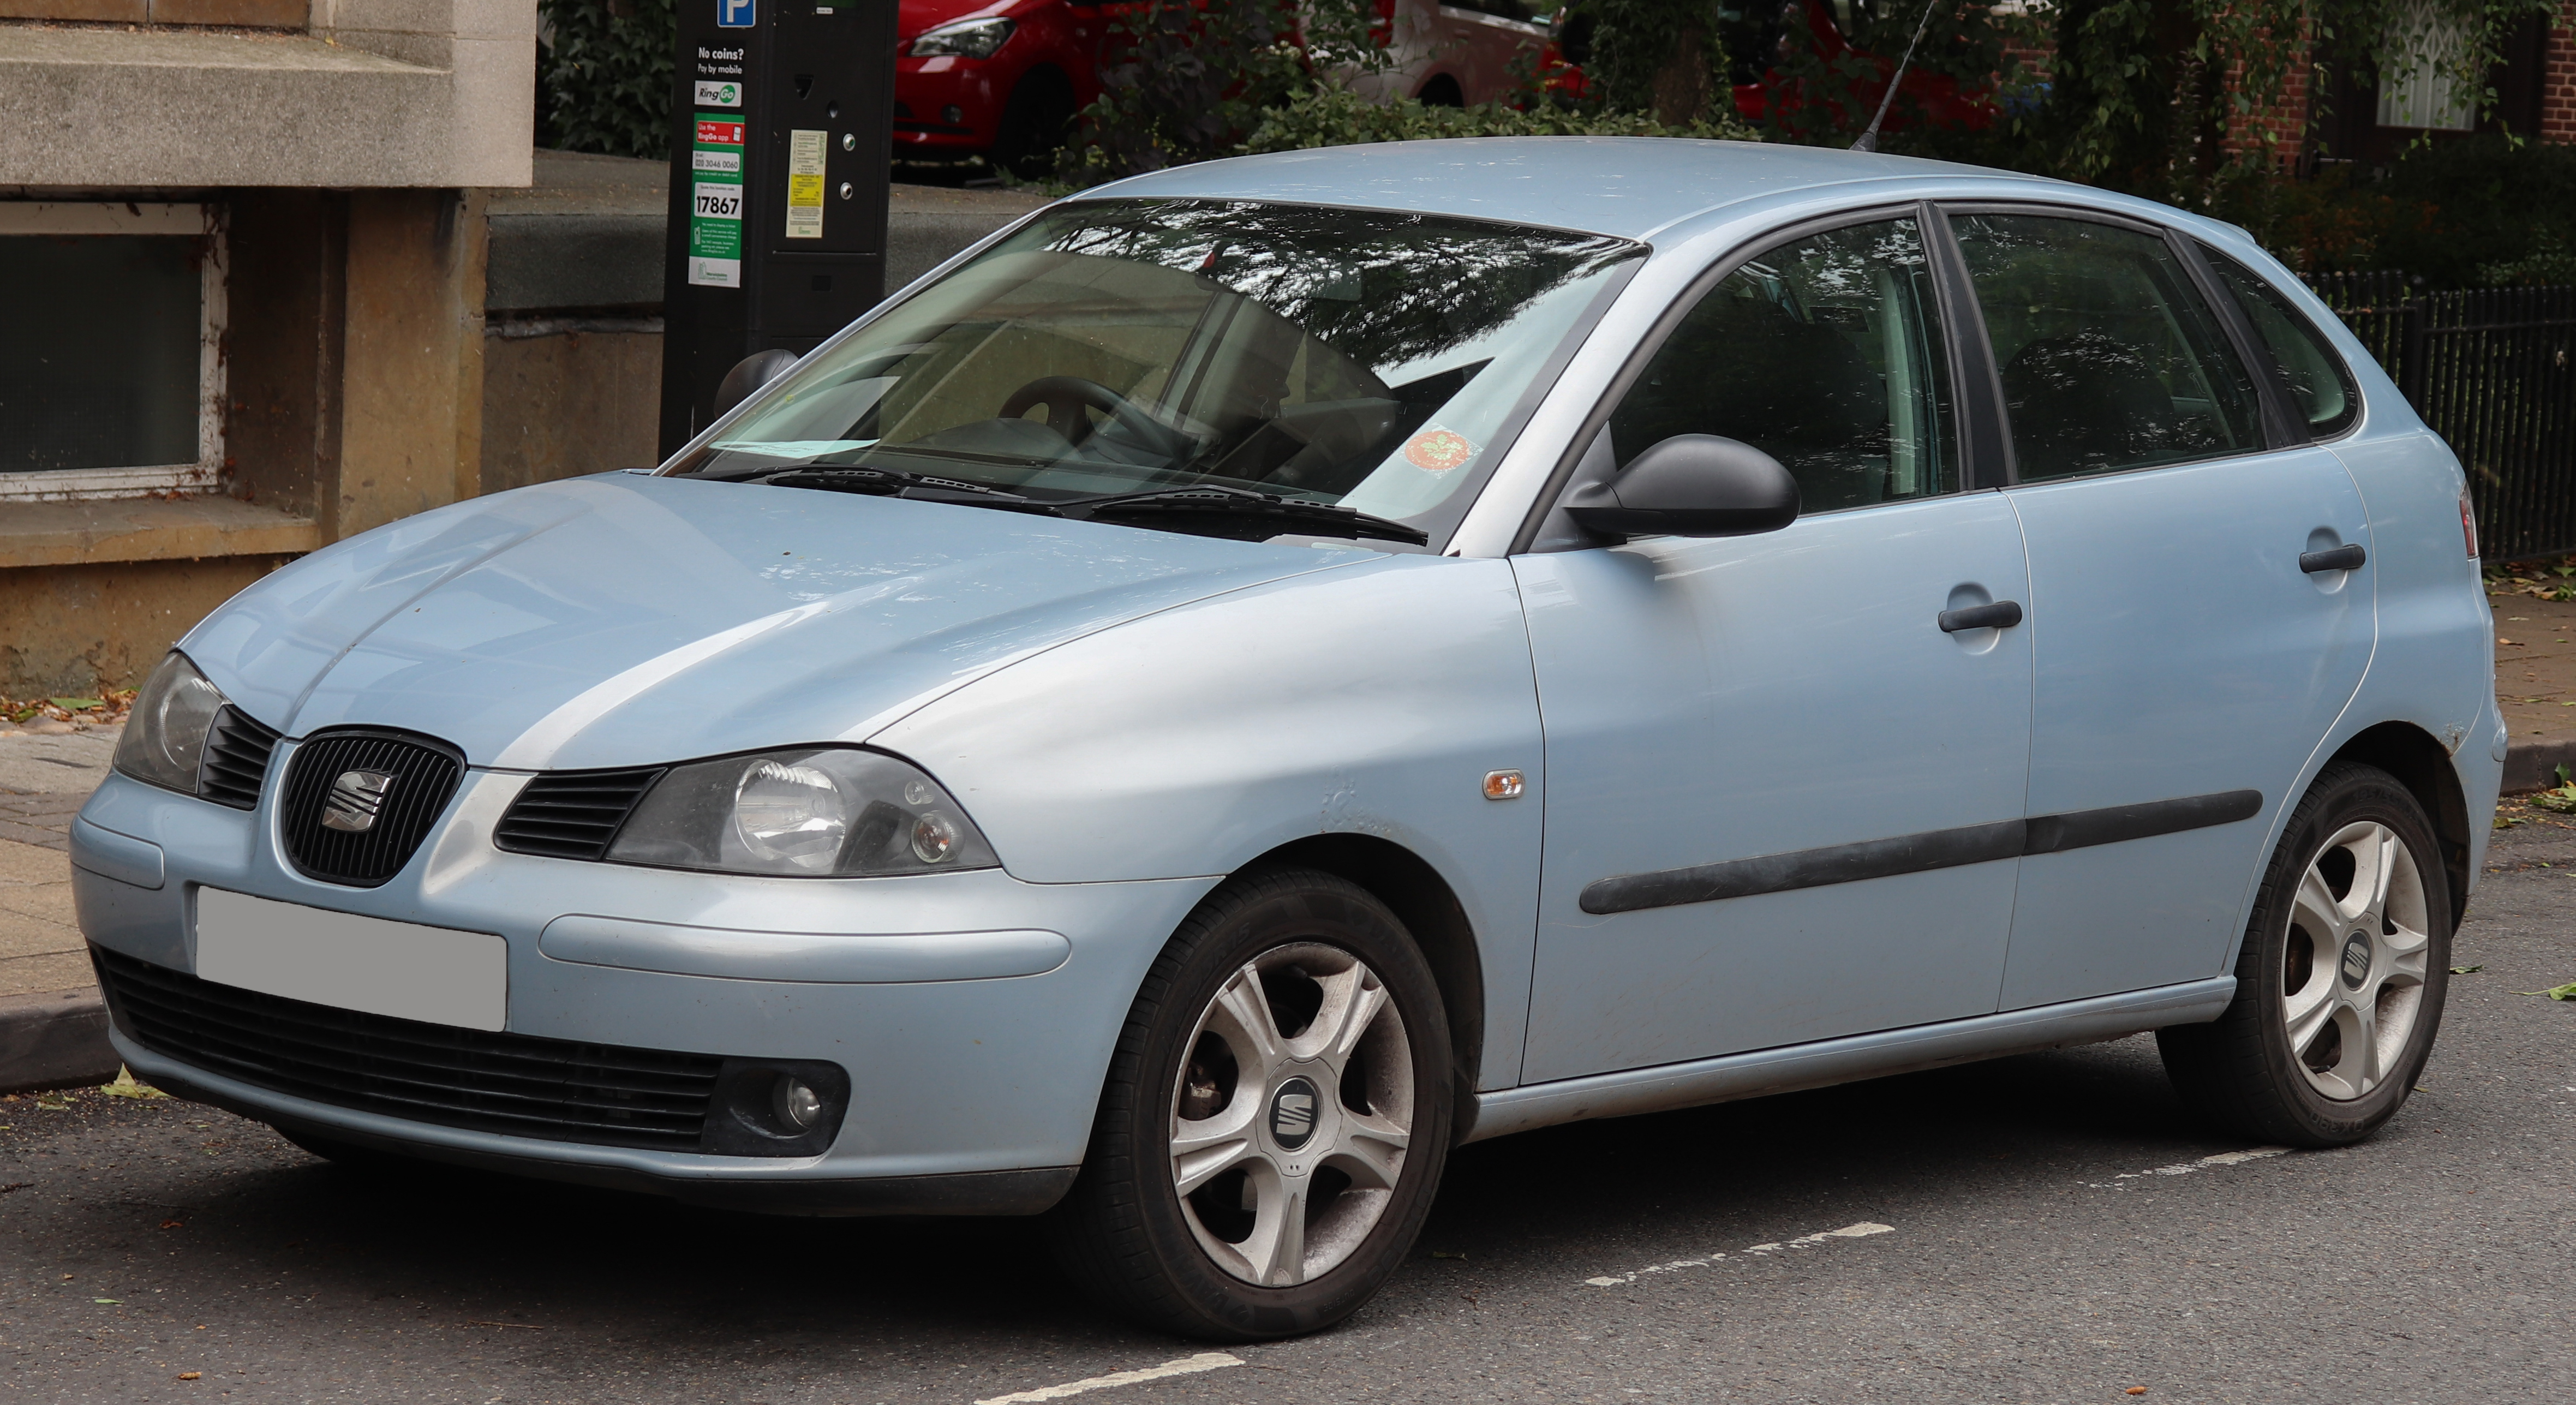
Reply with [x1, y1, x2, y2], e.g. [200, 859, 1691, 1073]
[0, 804, 2576, 1405]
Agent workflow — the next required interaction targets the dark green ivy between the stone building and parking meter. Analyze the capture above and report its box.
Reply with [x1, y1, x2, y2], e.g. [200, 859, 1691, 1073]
[536, 0, 680, 160]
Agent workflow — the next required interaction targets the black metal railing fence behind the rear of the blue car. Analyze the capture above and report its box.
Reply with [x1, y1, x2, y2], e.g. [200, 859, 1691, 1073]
[2308, 271, 2576, 562]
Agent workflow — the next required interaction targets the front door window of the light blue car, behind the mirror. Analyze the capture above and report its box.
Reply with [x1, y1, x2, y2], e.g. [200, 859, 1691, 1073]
[1610, 219, 1958, 513]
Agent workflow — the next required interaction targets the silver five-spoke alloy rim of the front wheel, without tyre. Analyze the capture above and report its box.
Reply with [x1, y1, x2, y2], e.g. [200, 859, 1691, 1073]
[1169, 941, 1414, 1287]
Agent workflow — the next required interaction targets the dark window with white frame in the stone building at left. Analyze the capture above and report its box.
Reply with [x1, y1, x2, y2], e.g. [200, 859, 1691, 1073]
[0, 201, 224, 503]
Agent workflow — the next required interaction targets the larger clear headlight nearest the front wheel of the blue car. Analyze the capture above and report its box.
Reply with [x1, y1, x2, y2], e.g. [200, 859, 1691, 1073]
[608, 748, 1000, 879]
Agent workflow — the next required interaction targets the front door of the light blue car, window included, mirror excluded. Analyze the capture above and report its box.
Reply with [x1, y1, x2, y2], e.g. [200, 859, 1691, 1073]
[1512, 219, 2030, 1083]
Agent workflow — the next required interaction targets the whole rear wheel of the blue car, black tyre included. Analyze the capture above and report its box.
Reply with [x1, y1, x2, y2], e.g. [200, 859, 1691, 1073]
[2156, 763, 2452, 1147]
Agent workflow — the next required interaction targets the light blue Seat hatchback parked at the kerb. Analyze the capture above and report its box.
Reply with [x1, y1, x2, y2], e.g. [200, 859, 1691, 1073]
[72, 139, 2504, 1338]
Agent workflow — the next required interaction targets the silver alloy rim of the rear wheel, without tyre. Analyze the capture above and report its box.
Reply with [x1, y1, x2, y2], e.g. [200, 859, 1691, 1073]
[2280, 820, 2432, 1101]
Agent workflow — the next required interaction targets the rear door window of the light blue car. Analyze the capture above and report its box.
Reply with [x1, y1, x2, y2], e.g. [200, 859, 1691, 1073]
[1953, 214, 2264, 482]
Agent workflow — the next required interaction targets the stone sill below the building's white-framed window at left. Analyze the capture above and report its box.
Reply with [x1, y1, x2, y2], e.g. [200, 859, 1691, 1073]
[0, 498, 322, 567]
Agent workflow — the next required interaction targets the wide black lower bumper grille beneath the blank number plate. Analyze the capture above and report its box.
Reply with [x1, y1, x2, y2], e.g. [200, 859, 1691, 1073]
[90, 946, 721, 1155]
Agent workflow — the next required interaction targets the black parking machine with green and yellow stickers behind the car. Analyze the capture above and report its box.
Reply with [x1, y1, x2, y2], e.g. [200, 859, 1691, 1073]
[662, 0, 896, 456]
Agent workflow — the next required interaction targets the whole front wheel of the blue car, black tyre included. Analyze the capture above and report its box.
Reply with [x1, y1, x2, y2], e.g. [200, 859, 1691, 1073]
[1051, 869, 1453, 1341]
